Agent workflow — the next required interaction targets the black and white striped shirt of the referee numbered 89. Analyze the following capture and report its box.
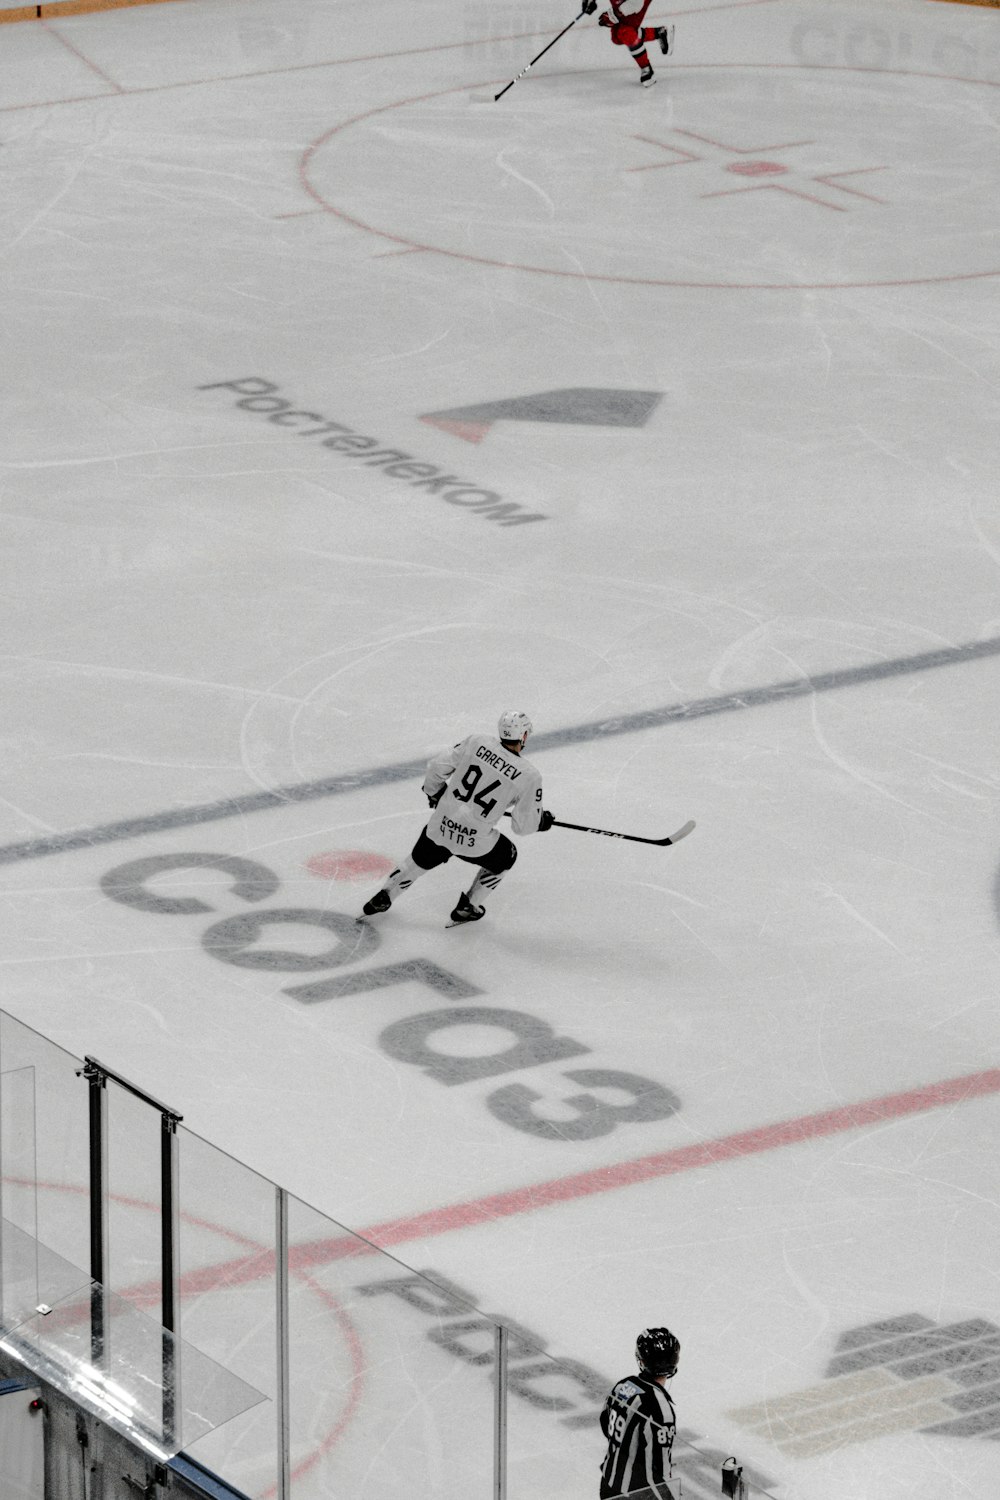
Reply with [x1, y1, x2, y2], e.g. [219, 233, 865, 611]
[601, 1376, 676, 1500]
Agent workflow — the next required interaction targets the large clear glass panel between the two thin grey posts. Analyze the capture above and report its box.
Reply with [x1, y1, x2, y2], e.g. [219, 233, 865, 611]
[288, 1199, 493, 1500]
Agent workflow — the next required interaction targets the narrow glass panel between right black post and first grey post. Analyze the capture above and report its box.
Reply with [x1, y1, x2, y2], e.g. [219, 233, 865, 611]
[177, 1127, 277, 1500]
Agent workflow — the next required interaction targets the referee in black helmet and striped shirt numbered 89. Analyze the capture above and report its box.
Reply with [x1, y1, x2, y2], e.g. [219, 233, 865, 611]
[601, 1328, 681, 1500]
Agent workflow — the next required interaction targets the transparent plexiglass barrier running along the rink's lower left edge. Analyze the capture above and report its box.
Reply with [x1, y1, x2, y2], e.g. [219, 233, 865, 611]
[0, 1013, 766, 1500]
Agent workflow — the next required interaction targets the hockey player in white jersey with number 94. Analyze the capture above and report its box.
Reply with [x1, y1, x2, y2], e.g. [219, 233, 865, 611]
[361, 710, 553, 923]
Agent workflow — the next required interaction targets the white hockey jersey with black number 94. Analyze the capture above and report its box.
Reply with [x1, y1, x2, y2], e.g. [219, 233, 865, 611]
[424, 735, 541, 857]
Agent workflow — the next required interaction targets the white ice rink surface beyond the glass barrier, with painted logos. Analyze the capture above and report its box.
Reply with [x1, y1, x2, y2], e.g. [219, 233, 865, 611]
[0, 0, 1000, 1500]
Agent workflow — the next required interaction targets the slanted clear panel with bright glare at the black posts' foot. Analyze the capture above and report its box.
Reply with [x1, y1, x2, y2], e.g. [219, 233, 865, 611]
[0, 1248, 264, 1458]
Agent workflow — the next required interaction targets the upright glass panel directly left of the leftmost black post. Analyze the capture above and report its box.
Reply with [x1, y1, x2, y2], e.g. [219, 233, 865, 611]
[0, 1013, 90, 1268]
